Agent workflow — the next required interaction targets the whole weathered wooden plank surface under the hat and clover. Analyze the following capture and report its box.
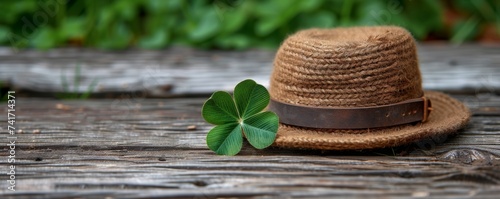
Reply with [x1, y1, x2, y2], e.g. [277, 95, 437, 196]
[0, 45, 500, 198]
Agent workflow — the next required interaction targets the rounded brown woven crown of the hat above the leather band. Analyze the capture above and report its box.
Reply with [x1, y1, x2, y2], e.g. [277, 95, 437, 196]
[270, 26, 423, 107]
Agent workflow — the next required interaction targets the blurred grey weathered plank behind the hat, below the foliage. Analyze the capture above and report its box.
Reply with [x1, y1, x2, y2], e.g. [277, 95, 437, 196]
[0, 44, 500, 96]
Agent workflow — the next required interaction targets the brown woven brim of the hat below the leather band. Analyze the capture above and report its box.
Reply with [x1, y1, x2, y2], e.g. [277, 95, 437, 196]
[274, 91, 470, 150]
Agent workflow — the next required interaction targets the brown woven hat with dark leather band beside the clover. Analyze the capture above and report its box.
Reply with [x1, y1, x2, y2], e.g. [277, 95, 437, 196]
[268, 26, 470, 150]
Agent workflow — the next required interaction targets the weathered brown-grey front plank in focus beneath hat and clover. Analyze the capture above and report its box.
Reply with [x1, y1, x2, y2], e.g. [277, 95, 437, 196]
[0, 94, 500, 198]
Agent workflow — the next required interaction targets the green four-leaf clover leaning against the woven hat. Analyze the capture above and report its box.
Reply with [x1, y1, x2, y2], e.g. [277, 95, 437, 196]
[201, 79, 279, 155]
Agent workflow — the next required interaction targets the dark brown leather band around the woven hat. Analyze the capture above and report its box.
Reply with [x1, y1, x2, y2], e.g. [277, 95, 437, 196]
[268, 97, 432, 129]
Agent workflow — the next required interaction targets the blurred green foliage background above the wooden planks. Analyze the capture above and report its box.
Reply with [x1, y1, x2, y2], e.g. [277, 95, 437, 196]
[0, 0, 500, 49]
